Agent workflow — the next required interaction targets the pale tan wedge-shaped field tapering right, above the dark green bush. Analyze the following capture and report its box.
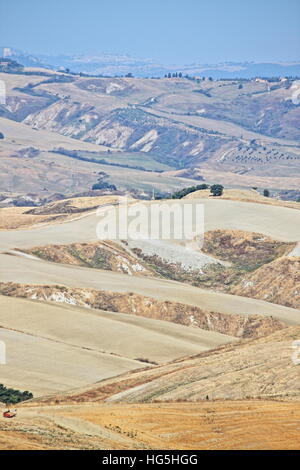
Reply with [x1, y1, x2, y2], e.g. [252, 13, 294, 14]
[0, 296, 234, 394]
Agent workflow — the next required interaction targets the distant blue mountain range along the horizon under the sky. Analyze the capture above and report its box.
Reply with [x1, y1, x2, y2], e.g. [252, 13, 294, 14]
[0, 47, 300, 79]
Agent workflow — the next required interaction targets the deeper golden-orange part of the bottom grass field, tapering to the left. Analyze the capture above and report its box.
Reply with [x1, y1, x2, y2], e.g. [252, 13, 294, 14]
[67, 402, 300, 449]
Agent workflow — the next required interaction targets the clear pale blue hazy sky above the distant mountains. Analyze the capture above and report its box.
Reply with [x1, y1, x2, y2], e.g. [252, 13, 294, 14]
[0, 0, 300, 64]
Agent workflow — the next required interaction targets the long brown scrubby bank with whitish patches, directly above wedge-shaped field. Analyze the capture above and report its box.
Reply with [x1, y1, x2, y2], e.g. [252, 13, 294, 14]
[0, 282, 287, 340]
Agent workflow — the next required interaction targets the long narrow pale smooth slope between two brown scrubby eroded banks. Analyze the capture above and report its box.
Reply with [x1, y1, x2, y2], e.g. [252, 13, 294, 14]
[0, 254, 300, 325]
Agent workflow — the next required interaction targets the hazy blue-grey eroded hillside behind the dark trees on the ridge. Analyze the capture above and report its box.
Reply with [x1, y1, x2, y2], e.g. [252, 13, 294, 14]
[0, 70, 300, 195]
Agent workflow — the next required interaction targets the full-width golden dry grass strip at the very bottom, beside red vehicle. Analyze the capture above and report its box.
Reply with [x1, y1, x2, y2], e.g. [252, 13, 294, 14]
[0, 400, 300, 450]
